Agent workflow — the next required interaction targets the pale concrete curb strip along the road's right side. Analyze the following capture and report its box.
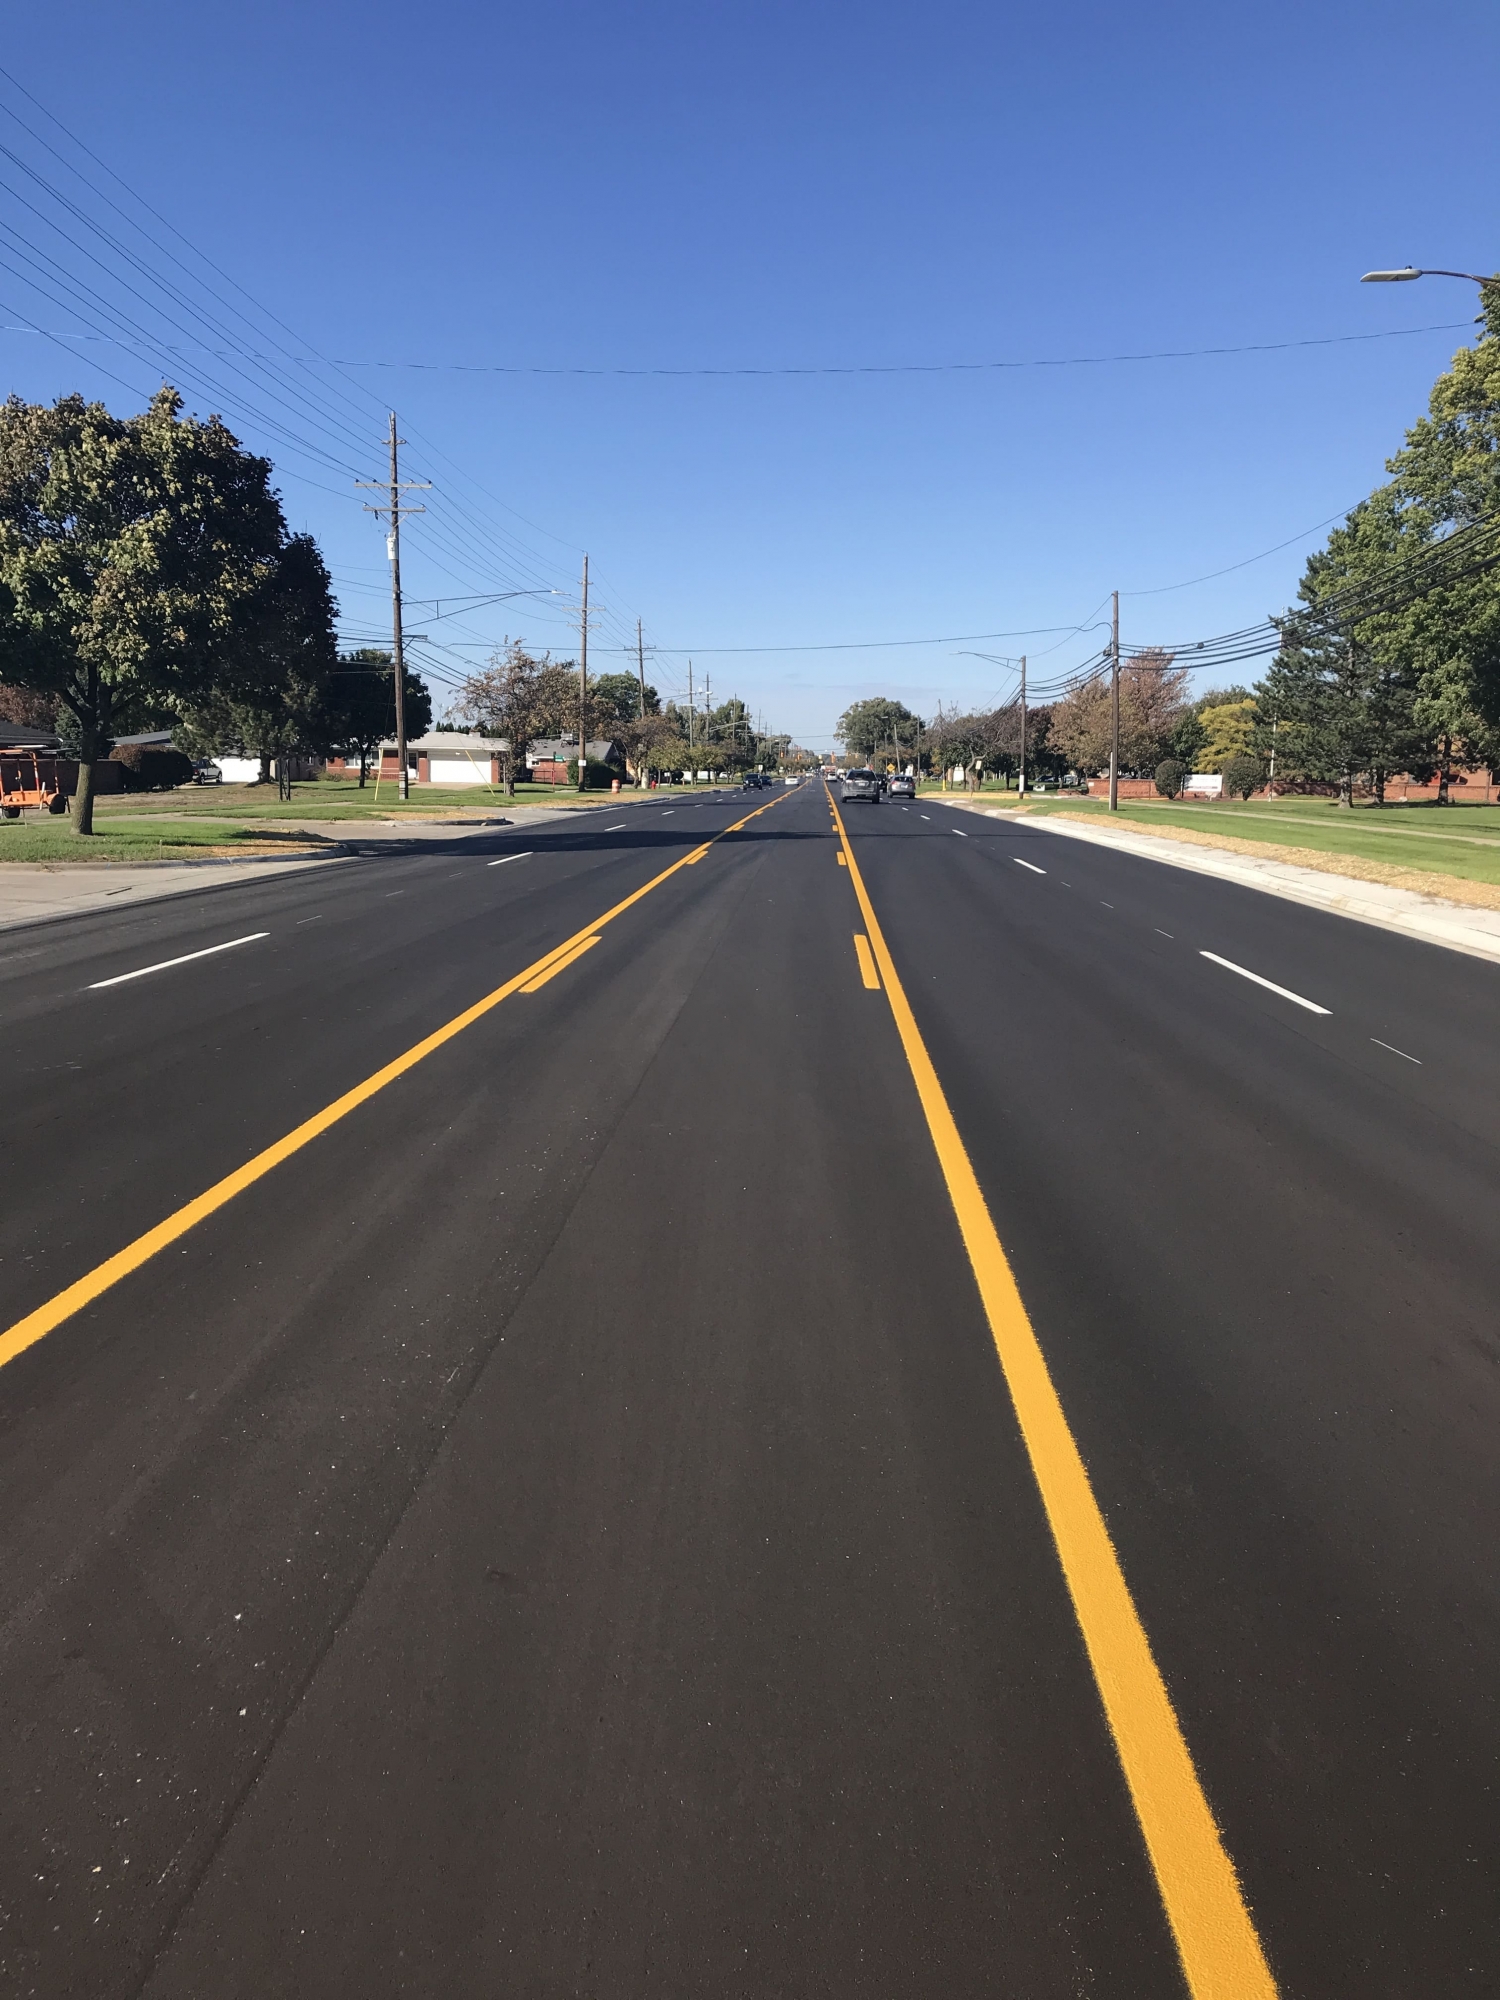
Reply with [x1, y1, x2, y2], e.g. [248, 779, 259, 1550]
[1000, 808, 1500, 964]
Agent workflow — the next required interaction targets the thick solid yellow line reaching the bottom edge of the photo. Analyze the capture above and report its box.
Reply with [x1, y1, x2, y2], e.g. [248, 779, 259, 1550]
[834, 788, 1276, 2000]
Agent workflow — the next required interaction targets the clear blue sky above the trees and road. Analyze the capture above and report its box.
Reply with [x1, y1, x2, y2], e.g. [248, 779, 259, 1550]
[0, 0, 1500, 744]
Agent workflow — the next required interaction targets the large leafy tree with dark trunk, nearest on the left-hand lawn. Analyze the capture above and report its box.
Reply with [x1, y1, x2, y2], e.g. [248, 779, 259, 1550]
[0, 388, 302, 834]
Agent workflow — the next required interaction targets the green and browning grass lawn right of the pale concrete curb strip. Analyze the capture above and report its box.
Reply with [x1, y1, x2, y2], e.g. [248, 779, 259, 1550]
[1030, 798, 1500, 882]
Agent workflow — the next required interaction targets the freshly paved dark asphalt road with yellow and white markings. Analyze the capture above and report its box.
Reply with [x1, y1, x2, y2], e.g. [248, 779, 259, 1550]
[0, 782, 1500, 2000]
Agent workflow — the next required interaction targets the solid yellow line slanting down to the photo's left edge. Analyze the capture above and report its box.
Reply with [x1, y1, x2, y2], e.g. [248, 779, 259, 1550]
[0, 798, 800, 1368]
